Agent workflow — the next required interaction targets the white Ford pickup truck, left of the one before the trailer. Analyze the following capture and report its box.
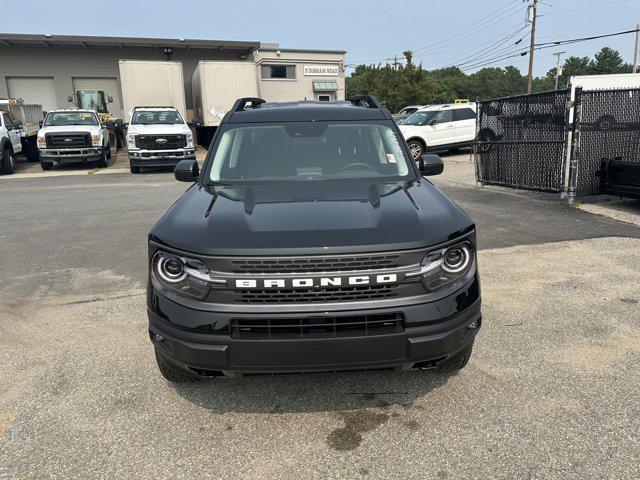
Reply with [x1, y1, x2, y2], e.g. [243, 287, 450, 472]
[38, 108, 111, 170]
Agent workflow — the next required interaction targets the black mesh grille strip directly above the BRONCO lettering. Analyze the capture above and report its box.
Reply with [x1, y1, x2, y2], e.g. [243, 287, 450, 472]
[231, 255, 400, 273]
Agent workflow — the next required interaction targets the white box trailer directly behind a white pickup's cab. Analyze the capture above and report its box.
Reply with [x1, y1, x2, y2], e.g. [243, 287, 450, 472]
[119, 60, 187, 123]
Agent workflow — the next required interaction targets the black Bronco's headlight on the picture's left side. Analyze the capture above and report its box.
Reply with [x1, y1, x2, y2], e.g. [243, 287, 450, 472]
[151, 252, 210, 300]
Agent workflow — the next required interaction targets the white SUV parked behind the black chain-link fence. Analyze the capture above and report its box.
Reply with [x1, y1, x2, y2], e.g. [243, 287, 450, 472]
[399, 103, 476, 159]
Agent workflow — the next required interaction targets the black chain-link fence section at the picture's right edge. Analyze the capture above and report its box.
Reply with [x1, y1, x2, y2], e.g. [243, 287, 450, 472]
[569, 88, 640, 197]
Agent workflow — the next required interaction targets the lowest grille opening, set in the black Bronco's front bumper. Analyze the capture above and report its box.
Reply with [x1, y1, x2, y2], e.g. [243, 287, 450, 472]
[230, 313, 405, 340]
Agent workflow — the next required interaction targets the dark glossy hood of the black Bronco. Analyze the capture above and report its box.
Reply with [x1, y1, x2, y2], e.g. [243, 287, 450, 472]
[151, 180, 473, 255]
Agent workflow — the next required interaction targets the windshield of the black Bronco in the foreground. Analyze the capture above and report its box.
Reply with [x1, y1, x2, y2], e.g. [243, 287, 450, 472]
[209, 121, 411, 182]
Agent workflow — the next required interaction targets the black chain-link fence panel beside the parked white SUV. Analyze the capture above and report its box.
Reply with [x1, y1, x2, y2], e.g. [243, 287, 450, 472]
[474, 90, 569, 192]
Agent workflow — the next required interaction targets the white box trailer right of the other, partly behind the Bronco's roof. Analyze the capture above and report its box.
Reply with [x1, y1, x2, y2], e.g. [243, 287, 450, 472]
[191, 60, 259, 128]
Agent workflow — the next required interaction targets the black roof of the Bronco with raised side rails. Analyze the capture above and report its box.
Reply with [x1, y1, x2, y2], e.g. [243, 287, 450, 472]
[228, 96, 391, 123]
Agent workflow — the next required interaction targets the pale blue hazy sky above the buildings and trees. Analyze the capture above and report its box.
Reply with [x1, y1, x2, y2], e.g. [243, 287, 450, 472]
[5, 0, 640, 75]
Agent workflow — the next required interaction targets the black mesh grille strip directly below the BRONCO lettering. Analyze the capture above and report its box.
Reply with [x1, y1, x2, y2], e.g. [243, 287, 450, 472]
[234, 284, 400, 303]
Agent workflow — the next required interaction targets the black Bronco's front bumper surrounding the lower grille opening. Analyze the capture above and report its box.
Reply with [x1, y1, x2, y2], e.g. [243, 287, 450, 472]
[147, 277, 482, 377]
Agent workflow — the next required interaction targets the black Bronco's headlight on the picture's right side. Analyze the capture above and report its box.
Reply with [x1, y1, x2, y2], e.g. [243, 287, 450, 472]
[420, 242, 475, 292]
